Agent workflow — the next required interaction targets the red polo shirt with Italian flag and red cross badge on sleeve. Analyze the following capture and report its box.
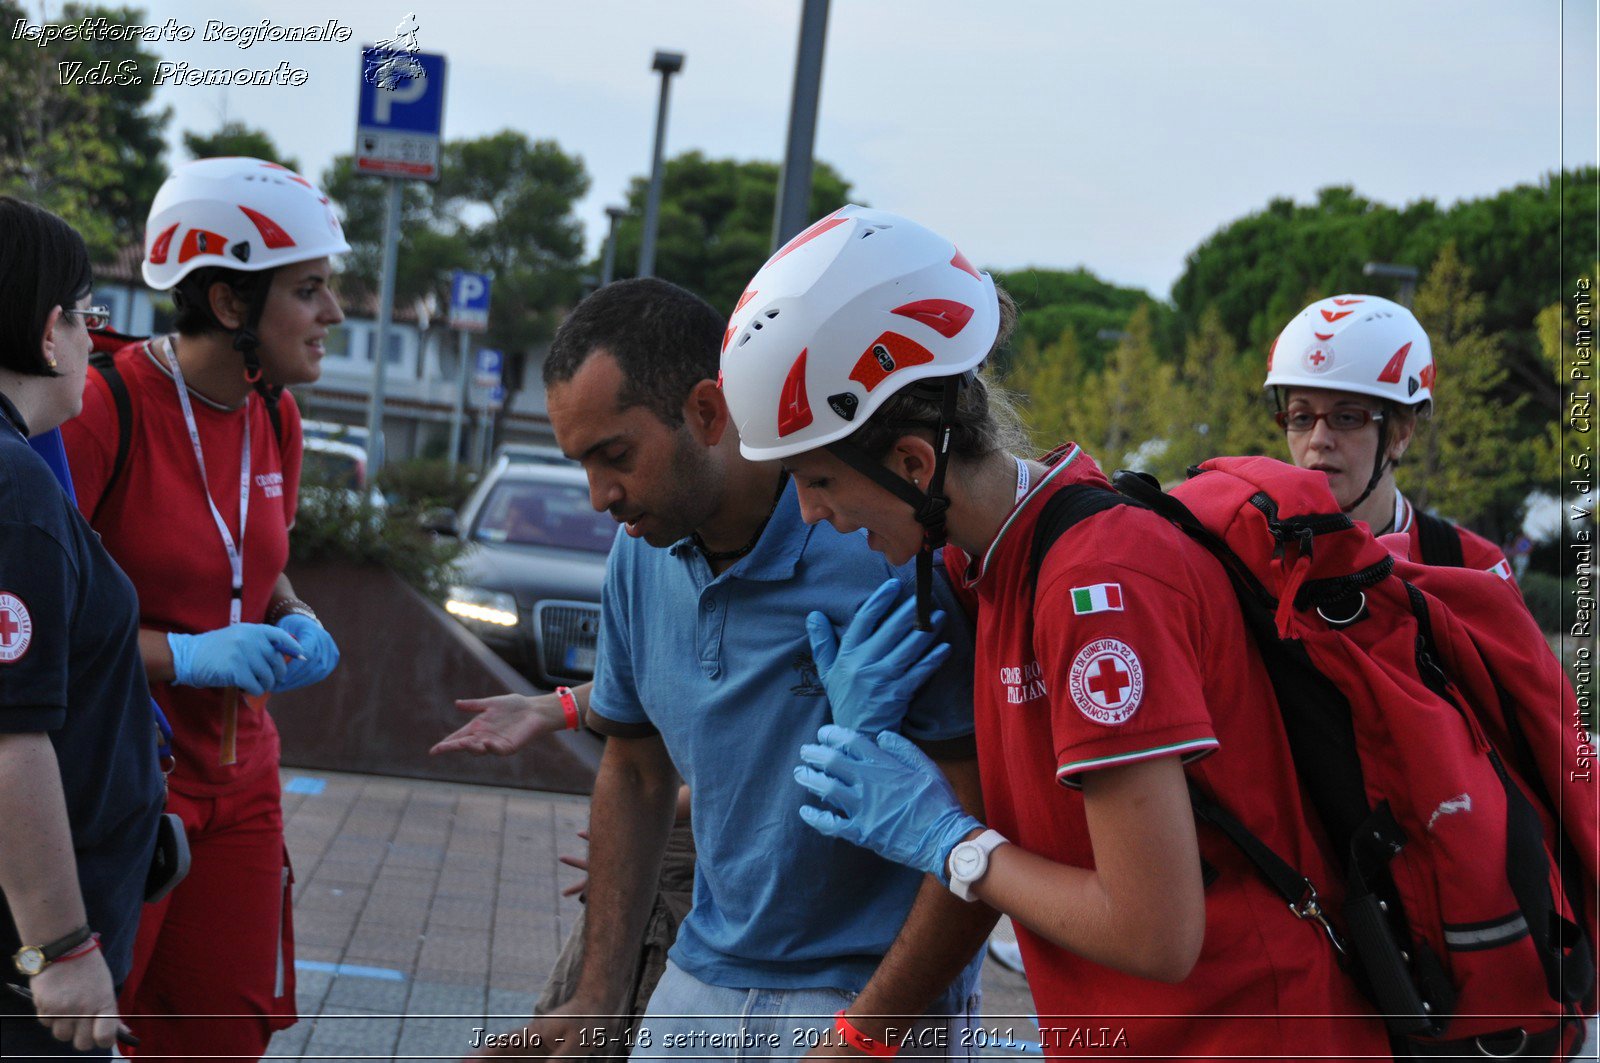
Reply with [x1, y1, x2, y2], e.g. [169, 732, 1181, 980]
[946, 447, 1389, 1060]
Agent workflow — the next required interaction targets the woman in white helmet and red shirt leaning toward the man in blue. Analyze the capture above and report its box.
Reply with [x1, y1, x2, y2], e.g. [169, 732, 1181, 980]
[722, 207, 1387, 1058]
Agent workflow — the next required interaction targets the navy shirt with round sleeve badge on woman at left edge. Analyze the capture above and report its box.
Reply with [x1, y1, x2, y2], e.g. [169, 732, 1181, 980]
[0, 395, 165, 986]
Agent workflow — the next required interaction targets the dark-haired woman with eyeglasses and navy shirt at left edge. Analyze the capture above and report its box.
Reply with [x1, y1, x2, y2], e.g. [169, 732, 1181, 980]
[0, 197, 162, 1057]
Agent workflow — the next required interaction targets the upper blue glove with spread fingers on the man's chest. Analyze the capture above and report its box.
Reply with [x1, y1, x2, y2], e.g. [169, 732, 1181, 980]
[805, 580, 950, 735]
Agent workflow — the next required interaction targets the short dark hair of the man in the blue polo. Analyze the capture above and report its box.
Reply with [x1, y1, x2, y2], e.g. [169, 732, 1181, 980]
[544, 277, 726, 427]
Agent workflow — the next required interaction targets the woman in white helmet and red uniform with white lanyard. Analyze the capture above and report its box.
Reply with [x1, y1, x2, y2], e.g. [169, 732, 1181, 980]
[64, 158, 350, 1058]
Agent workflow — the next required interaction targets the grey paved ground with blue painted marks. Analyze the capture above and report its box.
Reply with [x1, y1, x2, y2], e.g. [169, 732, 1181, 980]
[267, 770, 1035, 1060]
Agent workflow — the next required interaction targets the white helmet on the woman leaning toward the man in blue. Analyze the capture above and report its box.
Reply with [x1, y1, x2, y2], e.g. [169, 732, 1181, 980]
[722, 205, 1000, 461]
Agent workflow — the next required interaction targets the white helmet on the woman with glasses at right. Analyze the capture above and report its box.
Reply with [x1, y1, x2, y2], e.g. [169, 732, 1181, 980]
[1262, 295, 1435, 407]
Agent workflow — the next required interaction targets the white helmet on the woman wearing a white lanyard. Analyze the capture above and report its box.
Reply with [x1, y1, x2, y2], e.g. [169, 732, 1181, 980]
[142, 155, 350, 290]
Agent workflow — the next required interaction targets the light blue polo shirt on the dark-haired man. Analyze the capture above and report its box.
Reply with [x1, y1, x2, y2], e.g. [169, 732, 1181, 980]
[590, 483, 978, 996]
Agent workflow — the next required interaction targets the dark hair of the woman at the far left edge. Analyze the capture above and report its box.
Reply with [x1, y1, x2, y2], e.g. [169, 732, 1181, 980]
[0, 195, 94, 376]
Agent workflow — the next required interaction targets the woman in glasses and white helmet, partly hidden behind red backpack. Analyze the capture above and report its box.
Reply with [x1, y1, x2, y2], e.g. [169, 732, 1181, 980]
[1264, 295, 1515, 583]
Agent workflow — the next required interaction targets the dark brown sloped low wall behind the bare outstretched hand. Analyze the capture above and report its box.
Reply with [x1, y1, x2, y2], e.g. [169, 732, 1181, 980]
[270, 564, 602, 794]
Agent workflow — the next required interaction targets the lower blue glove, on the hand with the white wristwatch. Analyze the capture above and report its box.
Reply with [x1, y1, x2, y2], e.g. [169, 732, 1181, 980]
[795, 724, 984, 885]
